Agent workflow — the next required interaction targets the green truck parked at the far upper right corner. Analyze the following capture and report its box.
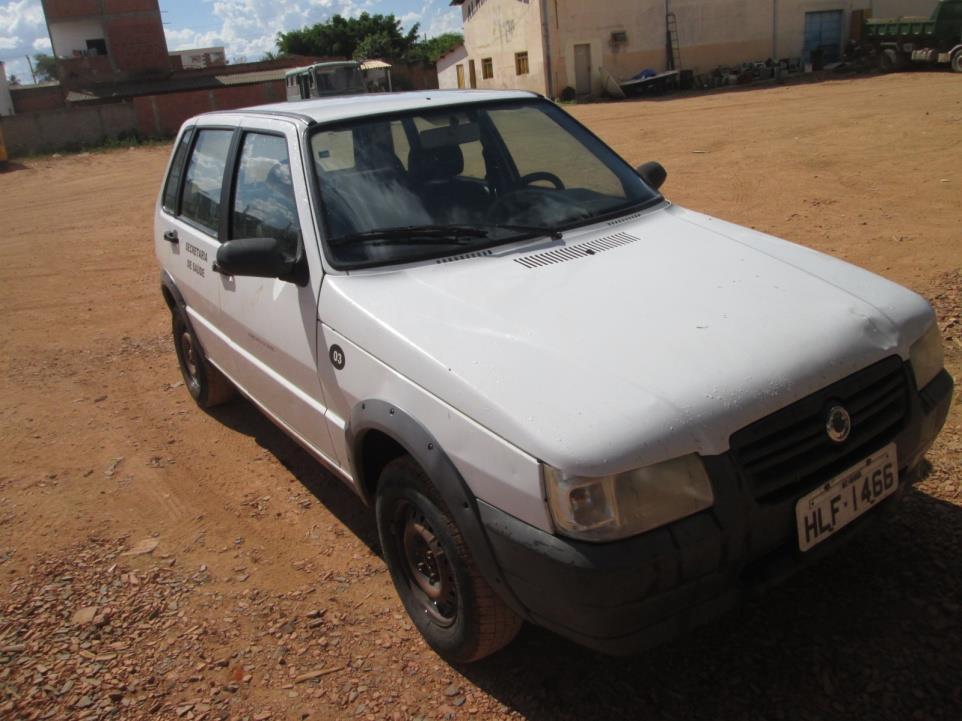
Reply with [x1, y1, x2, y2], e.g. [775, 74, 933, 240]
[863, 0, 962, 73]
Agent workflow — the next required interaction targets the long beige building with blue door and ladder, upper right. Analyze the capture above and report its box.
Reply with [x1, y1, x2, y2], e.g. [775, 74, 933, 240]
[438, 0, 936, 97]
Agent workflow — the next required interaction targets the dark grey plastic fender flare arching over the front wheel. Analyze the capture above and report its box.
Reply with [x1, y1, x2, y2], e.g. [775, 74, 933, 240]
[345, 400, 528, 618]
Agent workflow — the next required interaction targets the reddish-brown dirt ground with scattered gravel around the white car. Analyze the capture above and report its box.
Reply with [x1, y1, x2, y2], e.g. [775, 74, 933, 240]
[0, 72, 962, 721]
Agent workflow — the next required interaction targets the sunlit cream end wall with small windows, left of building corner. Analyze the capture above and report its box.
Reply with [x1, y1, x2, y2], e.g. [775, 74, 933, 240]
[450, 0, 548, 93]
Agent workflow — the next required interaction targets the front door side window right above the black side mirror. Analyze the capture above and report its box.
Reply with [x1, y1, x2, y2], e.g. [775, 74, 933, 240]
[230, 133, 301, 252]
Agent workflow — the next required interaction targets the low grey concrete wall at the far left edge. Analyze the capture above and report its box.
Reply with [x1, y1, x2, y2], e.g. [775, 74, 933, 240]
[0, 103, 137, 157]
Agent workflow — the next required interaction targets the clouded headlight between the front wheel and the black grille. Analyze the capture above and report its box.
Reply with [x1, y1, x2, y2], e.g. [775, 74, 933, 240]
[543, 455, 714, 541]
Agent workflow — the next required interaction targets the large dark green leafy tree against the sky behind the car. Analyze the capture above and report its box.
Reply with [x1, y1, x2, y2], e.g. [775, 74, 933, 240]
[277, 13, 419, 59]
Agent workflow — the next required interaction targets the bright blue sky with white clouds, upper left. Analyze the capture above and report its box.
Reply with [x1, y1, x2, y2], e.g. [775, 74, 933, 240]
[0, 0, 461, 83]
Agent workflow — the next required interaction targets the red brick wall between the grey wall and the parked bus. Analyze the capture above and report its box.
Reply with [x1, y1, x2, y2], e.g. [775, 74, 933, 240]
[134, 80, 287, 138]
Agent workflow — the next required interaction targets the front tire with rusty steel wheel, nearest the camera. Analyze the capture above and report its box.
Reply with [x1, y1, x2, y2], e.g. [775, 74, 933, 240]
[375, 456, 521, 663]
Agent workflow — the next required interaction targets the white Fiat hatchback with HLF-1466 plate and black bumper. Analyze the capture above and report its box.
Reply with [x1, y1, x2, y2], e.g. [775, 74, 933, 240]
[155, 92, 953, 662]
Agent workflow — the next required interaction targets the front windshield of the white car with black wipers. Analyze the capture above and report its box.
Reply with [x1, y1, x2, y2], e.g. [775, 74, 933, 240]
[311, 99, 661, 267]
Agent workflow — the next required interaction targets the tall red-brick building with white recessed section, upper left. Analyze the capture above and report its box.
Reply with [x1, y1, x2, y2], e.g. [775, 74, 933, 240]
[42, 0, 171, 89]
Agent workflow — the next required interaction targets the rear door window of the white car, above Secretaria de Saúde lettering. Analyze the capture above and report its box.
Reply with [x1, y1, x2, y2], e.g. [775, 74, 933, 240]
[180, 129, 234, 235]
